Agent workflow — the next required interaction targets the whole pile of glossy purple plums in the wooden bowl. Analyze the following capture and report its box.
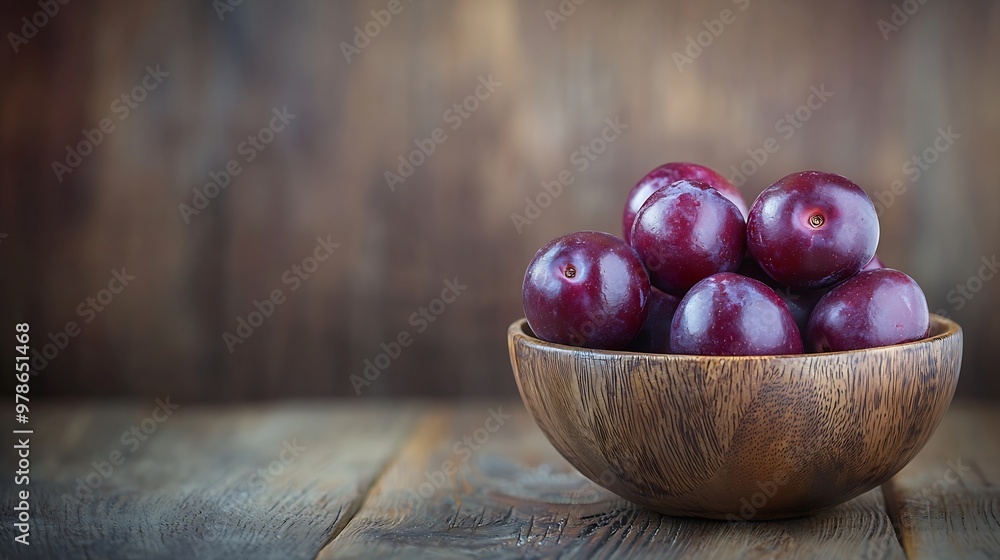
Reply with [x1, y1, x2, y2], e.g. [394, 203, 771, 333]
[522, 163, 930, 356]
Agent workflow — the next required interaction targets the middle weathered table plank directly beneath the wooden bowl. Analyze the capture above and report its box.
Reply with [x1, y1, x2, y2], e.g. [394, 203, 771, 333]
[319, 403, 902, 559]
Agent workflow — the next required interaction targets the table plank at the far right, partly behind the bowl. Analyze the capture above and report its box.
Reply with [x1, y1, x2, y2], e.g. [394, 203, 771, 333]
[883, 402, 1000, 559]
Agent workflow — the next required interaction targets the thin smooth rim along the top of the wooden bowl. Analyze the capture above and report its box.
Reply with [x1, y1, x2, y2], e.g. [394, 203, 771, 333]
[507, 313, 962, 361]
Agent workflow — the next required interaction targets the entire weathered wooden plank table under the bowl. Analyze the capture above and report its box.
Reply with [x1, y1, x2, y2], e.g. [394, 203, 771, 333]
[0, 401, 1000, 559]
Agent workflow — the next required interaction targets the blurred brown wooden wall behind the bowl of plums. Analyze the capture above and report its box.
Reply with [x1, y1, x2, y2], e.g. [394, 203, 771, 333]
[0, 0, 1000, 402]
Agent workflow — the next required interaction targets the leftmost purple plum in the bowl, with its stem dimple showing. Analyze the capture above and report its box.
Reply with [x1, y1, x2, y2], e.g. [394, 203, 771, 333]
[522, 231, 650, 350]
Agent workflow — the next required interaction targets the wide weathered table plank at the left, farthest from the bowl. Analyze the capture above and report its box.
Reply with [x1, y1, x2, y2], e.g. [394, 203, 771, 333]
[0, 401, 420, 559]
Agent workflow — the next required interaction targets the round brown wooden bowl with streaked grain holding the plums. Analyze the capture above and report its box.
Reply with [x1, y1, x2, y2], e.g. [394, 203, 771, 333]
[507, 315, 962, 520]
